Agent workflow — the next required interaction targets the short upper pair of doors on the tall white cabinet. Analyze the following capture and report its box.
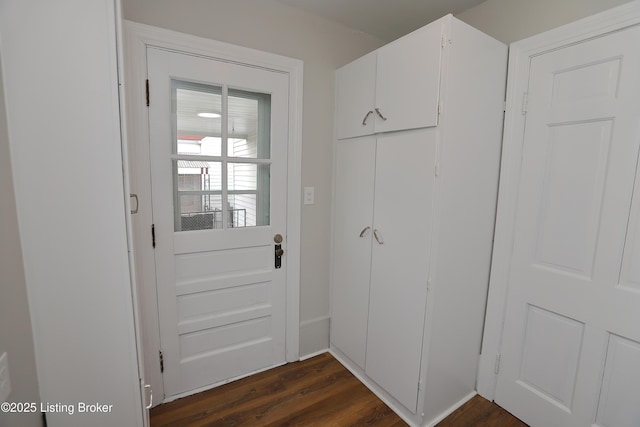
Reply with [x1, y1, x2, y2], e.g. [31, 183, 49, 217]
[336, 20, 445, 139]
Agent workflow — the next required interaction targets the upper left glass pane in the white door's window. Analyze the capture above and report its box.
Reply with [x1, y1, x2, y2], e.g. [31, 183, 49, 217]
[171, 80, 222, 156]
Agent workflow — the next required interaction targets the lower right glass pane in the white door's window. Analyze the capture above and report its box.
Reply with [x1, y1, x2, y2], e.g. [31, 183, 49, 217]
[227, 163, 270, 228]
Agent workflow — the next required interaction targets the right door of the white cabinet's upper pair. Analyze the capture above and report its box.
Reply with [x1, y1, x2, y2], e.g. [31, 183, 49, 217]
[375, 20, 446, 132]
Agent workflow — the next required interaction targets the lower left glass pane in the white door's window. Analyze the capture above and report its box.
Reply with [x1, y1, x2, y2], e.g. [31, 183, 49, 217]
[173, 160, 222, 231]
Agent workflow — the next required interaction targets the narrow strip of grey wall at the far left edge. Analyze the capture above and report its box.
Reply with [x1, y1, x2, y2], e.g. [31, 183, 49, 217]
[0, 50, 42, 427]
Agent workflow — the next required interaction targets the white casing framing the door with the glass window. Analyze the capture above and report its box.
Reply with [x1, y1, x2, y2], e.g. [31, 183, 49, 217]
[126, 22, 302, 404]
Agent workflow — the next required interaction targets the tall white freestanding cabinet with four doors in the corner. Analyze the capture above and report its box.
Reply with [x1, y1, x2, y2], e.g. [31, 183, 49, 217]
[330, 15, 507, 425]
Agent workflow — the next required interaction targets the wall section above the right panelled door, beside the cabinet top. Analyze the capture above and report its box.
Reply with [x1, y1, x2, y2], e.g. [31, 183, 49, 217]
[456, 0, 629, 43]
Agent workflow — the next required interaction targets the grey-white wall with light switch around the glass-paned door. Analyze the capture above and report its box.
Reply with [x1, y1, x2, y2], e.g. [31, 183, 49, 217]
[123, 0, 383, 355]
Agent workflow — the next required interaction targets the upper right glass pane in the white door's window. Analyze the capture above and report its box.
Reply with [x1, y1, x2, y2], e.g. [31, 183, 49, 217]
[227, 89, 271, 159]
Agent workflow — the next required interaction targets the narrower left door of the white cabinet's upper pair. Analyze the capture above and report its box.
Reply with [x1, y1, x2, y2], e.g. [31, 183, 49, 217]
[336, 52, 376, 139]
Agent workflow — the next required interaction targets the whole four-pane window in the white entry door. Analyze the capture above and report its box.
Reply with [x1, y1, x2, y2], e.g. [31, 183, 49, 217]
[171, 80, 271, 231]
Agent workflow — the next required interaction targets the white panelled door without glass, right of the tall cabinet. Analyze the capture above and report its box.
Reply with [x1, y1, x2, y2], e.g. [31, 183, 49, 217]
[496, 27, 640, 427]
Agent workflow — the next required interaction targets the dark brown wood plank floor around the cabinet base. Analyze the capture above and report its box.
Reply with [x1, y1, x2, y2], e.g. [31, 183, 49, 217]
[151, 353, 526, 427]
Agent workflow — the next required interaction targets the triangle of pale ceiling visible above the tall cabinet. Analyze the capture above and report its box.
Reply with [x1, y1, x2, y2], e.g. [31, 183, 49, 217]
[277, 0, 484, 42]
